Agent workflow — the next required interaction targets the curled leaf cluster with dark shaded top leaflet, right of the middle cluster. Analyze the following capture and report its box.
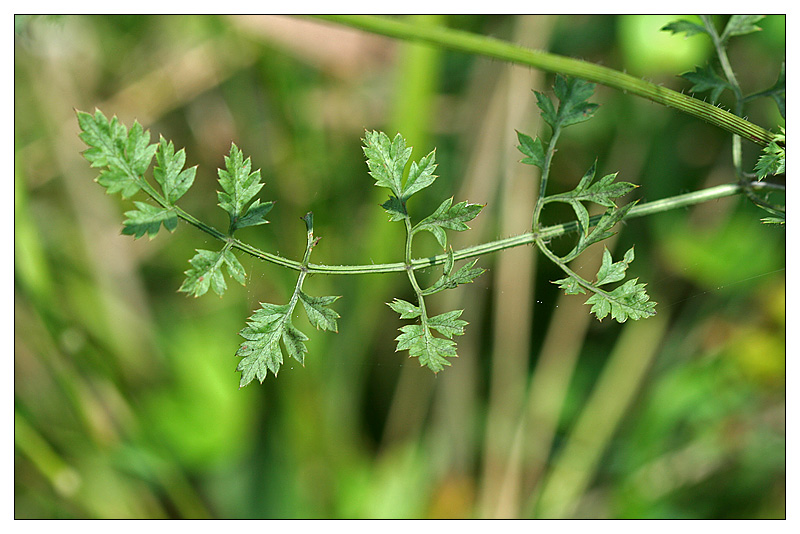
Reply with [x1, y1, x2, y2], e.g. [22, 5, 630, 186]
[517, 76, 656, 323]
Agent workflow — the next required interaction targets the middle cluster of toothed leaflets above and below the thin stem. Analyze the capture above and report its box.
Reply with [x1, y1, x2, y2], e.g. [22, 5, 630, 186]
[363, 131, 484, 373]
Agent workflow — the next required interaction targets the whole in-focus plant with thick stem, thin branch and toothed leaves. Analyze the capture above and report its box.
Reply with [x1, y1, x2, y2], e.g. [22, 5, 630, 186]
[77, 17, 786, 387]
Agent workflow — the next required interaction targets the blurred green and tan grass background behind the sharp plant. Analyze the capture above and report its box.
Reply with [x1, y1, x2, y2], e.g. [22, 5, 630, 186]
[14, 15, 786, 518]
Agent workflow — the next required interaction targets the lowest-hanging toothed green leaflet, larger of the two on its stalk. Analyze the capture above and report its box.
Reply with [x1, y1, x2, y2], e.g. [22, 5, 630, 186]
[236, 303, 308, 388]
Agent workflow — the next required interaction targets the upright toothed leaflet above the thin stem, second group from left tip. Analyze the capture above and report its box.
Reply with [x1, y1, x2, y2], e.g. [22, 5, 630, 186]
[217, 143, 272, 233]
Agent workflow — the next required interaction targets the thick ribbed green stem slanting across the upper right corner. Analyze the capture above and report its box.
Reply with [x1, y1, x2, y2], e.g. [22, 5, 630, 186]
[315, 15, 775, 146]
